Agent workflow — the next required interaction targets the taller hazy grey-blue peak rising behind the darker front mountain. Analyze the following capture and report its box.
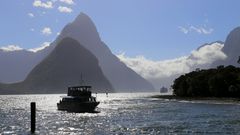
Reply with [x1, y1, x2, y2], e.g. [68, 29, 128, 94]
[57, 13, 154, 92]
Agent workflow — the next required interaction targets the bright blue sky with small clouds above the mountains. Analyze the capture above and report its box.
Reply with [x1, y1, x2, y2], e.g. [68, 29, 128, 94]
[0, 0, 240, 60]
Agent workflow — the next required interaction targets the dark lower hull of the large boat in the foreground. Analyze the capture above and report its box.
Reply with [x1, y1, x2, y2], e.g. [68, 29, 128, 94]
[57, 102, 99, 113]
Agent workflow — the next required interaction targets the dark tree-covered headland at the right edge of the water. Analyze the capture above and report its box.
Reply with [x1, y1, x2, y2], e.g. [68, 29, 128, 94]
[154, 65, 240, 100]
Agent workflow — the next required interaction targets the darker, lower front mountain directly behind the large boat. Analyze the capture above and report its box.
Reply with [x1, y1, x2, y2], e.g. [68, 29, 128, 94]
[0, 38, 113, 94]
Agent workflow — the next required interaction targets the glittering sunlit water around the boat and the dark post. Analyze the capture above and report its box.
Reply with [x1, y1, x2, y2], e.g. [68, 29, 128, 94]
[0, 93, 240, 135]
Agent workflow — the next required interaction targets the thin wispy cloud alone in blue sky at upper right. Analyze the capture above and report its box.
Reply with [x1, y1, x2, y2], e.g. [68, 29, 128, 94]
[178, 25, 214, 35]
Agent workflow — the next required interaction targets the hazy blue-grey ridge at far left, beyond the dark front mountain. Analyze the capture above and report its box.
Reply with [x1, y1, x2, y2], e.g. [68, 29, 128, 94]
[0, 50, 39, 83]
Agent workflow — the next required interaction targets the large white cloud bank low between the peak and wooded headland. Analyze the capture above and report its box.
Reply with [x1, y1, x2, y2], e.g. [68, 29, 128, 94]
[117, 42, 227, 88]
